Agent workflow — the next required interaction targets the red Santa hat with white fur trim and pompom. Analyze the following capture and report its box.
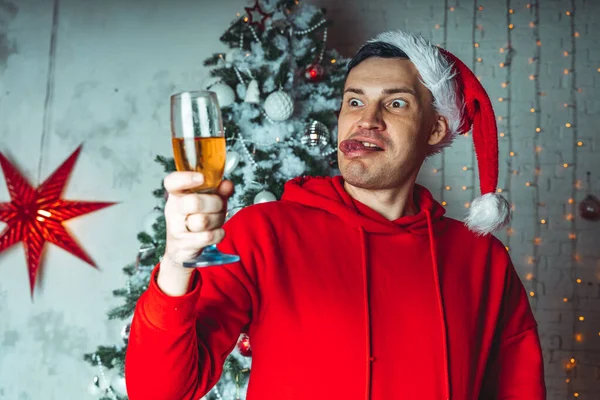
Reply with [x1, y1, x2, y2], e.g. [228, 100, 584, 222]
[370, 30, 512, 235]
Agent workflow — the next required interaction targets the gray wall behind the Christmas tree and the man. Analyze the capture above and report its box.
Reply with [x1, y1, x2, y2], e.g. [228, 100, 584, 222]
[0, 0, 600, 400]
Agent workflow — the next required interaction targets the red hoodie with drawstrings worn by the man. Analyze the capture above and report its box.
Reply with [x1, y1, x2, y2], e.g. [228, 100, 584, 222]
[126, 177, 545, 400]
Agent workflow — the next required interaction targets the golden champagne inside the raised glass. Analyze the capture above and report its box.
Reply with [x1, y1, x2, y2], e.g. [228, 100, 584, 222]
[172, 137, 227, 193]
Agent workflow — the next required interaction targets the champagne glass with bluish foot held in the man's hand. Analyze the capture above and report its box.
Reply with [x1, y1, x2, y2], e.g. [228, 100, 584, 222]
[171, 91, 240, 268]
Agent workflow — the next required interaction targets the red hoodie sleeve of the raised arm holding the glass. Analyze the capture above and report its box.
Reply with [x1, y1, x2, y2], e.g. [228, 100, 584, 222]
[125, 214, 258, 400]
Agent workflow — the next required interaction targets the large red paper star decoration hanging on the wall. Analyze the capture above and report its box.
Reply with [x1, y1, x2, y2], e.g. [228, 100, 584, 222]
[0, 146, 115, 297]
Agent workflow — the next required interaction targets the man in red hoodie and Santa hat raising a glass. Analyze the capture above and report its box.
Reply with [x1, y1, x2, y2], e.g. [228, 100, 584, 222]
[126, 31, 545, 400]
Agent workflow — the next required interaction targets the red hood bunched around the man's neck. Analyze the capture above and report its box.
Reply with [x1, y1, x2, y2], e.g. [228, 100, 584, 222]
[282, 175, 446, 235]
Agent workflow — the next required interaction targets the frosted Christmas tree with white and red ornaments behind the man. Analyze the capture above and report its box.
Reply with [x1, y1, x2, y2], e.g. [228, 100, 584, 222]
[84, 0, 348, 400]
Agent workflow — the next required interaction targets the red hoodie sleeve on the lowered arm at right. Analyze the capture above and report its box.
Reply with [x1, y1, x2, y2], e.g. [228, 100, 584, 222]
[479, 242, 546, 400]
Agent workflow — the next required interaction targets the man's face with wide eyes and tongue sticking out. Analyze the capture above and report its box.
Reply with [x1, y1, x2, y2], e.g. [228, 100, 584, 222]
[338, 57, 441, 189]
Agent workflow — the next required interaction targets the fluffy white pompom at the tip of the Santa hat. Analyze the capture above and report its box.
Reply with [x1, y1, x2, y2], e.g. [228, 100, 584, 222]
[465, 193, 512, 235]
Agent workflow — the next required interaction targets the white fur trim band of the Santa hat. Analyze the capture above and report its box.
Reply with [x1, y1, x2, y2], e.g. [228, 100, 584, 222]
[369, 30, 463, 155]
